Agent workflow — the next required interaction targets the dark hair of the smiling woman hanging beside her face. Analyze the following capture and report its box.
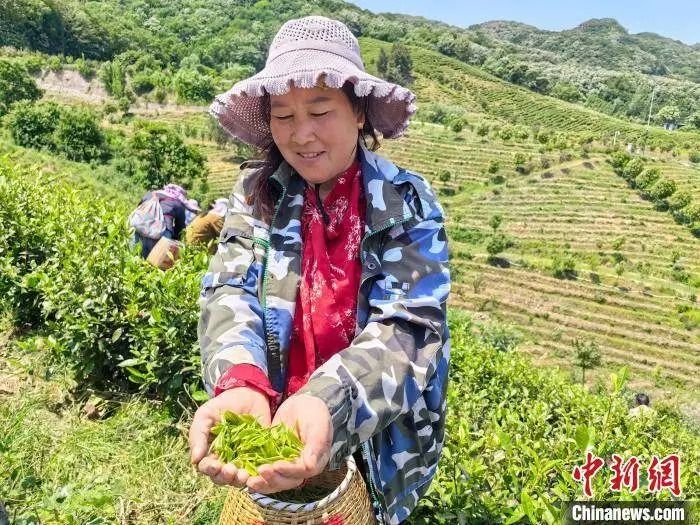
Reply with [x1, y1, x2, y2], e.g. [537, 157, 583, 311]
[248, 82, 380, 222]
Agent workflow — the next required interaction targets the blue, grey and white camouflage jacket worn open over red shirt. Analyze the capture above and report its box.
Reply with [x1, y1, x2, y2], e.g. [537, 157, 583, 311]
[199, 143, 450, 524]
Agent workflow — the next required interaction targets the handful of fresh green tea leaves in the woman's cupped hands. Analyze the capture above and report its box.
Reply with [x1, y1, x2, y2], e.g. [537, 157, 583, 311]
[210, 410, 304, 476]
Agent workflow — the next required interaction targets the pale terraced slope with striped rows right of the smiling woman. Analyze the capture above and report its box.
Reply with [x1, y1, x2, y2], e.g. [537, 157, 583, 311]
[445, 160, 700, 411]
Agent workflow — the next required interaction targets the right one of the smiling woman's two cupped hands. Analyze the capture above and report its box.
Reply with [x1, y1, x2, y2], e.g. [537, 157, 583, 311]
[246, 394, 333, 494]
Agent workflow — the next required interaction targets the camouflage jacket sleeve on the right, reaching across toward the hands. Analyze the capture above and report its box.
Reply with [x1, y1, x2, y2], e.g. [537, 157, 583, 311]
[299, 216, 450, 468]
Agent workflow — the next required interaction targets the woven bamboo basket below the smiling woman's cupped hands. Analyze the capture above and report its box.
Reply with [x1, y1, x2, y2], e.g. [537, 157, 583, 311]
[219, 456, 376, 525]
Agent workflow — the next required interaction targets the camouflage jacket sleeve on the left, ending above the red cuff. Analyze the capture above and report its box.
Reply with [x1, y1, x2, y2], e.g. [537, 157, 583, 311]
[198, 172, 269, 395]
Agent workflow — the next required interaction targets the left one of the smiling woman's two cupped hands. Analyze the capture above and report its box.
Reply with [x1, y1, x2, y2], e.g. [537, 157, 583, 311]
[189, 387, 270, 487]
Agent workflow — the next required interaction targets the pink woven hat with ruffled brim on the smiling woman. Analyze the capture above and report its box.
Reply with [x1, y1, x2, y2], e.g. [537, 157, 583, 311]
[209, 16, 416, 148]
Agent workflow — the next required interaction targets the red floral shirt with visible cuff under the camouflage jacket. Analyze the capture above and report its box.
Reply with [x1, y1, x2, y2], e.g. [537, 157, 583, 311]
[214, 160, 365, 407]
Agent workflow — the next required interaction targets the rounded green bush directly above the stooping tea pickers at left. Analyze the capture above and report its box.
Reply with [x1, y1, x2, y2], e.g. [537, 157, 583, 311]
[120, 121, 207, 194]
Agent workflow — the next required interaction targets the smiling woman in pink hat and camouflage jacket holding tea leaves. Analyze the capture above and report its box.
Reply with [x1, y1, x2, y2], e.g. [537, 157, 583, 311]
[190, 16, 450, 524]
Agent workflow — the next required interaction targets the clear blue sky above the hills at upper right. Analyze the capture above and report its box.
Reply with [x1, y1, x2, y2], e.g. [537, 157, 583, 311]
[349, 0, 700, 44]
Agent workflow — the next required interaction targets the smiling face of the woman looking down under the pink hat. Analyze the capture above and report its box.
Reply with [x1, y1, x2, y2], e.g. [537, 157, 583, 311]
[270, 87, 364, 184]
